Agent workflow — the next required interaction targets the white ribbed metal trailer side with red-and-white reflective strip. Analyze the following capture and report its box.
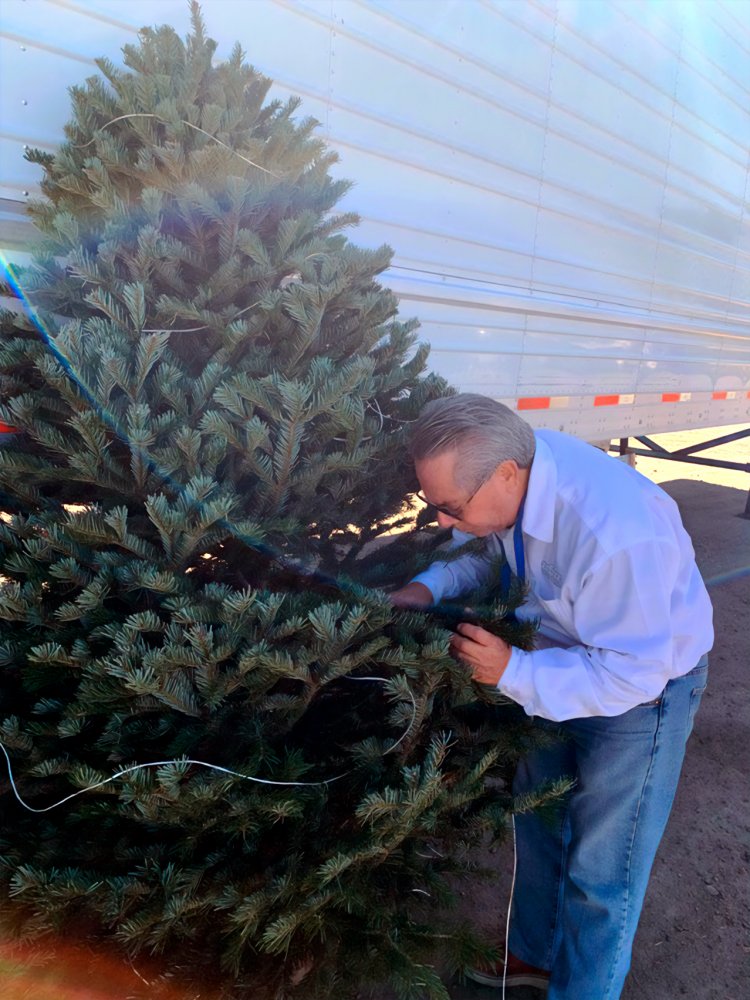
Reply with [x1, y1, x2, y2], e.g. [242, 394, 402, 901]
[0, 0, 750, 439]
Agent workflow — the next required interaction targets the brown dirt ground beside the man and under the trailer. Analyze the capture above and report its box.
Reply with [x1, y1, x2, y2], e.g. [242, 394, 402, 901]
[440, 427, 750, 1000]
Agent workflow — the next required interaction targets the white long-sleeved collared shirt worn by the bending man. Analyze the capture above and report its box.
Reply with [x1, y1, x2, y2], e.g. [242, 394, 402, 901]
[415, 430, 713, 721]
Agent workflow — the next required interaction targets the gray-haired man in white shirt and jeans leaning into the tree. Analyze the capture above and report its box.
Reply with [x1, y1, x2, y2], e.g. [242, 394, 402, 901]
[392, 394, 713, 1000]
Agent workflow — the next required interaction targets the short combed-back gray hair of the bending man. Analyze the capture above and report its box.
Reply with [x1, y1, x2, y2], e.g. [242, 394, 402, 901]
[409, 392, 536, 490]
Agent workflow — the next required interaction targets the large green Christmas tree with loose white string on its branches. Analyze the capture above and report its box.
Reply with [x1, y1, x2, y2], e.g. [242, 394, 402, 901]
[0, 5, 552, 1000]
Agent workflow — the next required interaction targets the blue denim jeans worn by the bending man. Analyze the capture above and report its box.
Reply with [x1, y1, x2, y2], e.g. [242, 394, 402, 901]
[509, 657, 708, 1000]
